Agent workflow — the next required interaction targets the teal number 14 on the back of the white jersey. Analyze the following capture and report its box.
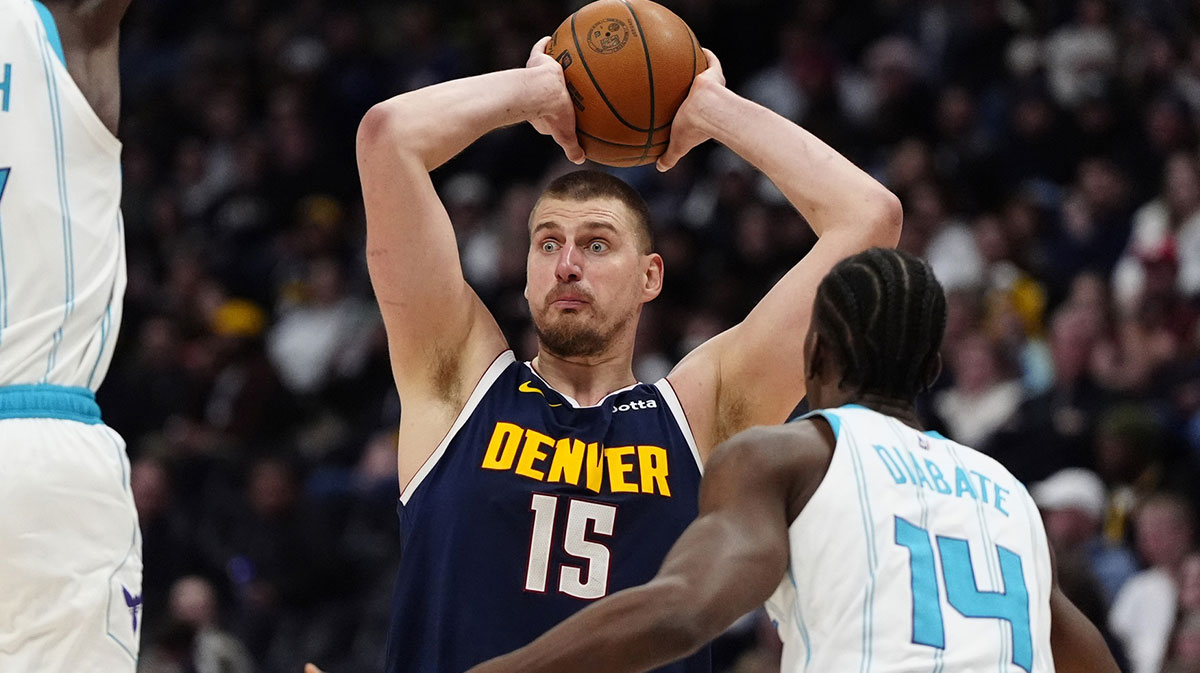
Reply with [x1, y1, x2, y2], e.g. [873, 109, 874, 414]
[895, 517, 1033, 671]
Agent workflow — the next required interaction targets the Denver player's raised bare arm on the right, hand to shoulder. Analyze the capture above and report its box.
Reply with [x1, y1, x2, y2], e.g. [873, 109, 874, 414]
[659, 52, 902, 453]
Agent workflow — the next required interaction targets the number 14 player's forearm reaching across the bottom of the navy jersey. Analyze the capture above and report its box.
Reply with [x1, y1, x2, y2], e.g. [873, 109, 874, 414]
[468, 581, 705, 673]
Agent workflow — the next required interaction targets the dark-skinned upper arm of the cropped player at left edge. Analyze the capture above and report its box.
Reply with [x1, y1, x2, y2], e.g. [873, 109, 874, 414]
[46, 0, 131, 136]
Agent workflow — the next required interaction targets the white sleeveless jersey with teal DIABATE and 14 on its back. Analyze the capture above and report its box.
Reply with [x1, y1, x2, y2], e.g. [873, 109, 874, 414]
[767, 404, 1054, 673]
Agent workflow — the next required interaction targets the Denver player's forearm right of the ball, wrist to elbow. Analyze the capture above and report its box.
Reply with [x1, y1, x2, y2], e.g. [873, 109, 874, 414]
[700, 86, 902, 241]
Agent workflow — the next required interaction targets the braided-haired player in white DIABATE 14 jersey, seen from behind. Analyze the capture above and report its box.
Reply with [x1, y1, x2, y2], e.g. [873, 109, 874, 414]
[473, 248, 1117, 673]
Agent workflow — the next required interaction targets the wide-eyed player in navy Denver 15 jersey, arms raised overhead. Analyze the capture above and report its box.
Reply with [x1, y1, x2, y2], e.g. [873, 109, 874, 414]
[358, 38, 901, 673]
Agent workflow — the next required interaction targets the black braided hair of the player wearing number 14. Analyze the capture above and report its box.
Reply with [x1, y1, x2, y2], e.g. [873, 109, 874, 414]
[812, 247, 946, 399]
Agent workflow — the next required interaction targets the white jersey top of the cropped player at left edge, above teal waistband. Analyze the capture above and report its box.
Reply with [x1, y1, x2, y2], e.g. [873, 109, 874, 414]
[0, 0, 125, 390]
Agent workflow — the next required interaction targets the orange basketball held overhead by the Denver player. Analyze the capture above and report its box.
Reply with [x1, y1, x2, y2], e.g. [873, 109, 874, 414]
[546, 0, 708, 166]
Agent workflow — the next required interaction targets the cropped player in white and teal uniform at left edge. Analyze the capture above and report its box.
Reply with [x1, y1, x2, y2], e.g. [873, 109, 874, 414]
[0, 0, 142, 673]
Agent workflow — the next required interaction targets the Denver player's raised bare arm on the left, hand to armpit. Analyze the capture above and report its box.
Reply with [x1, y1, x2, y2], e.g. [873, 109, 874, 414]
[358, 41, 582, 407]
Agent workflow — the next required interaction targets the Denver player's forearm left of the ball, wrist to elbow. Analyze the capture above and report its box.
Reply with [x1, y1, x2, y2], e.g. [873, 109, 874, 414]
[358, 68, 547, 170]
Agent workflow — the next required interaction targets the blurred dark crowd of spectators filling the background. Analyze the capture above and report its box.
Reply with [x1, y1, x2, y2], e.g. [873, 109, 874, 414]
[108, 0, 1200, 673]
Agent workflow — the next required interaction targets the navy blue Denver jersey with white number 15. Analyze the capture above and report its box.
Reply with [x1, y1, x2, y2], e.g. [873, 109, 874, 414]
[386, 353, 709, 673]
